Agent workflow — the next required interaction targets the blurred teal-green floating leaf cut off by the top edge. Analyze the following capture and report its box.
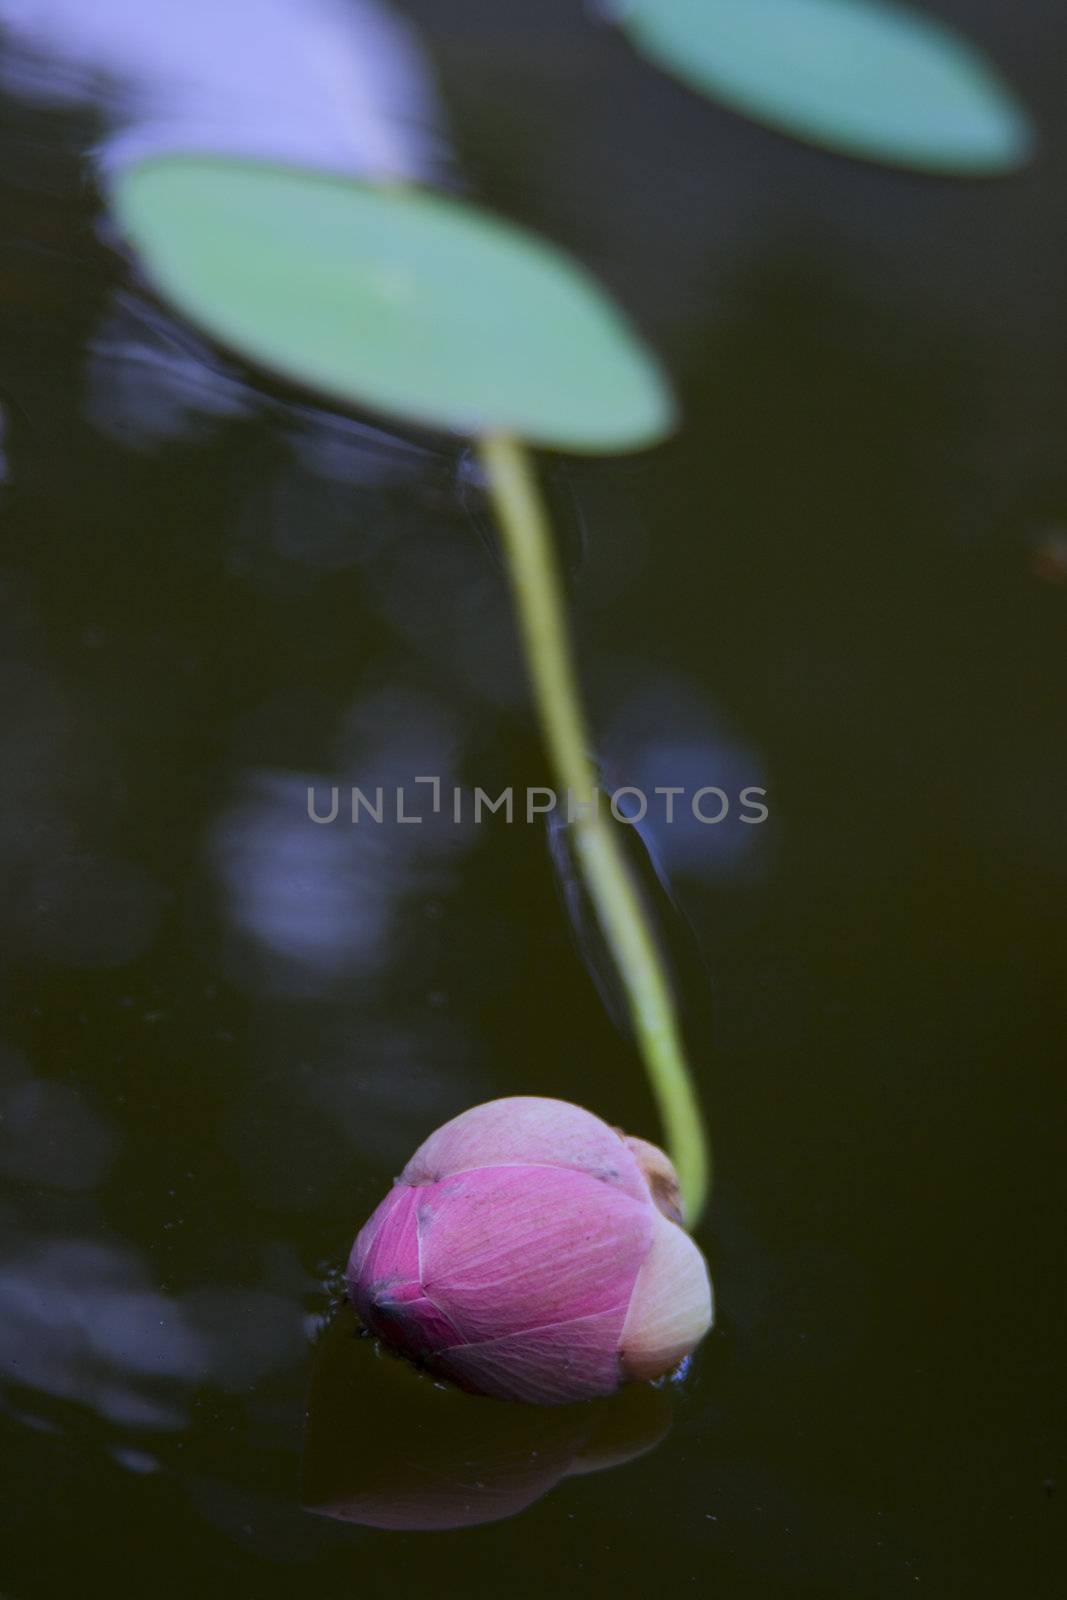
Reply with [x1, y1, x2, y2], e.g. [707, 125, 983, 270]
[616, 0, 1033, 174]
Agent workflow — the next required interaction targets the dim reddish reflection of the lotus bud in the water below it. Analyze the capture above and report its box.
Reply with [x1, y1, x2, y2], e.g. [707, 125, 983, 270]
[302, 1307, 670, 1531]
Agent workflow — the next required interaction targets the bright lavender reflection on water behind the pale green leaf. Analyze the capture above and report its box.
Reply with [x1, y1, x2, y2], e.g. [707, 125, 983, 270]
[0, 0, 443, 179]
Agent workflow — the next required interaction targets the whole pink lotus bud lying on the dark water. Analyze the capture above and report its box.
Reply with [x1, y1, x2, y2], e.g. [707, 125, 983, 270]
[347, 1096, 712, 1405]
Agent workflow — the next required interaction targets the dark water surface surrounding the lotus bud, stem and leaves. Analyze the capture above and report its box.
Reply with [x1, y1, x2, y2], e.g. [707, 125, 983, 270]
[0, 0, 1067, 1600]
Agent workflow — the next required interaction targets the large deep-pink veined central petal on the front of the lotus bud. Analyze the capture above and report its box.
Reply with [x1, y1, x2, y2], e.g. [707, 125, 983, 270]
[414, 1166, 656, 1344]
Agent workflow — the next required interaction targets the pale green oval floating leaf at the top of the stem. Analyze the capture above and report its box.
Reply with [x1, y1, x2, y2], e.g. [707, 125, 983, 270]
[114, 157, 673, 451]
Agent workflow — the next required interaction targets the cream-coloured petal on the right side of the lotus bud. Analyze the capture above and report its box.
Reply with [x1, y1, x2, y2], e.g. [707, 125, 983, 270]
[619, 1211, 712, 1378]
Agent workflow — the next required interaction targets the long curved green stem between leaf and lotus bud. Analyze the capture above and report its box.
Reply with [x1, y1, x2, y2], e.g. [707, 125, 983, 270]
[480, 434, 710, 1226]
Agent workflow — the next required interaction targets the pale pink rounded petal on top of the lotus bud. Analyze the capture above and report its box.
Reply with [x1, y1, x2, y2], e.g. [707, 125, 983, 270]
[400, 1094, 646, 1200]
